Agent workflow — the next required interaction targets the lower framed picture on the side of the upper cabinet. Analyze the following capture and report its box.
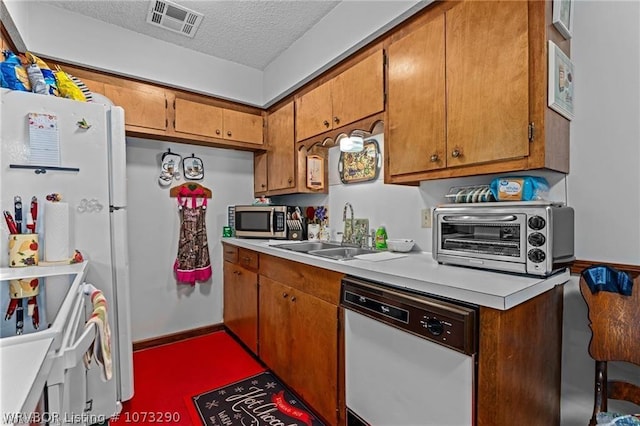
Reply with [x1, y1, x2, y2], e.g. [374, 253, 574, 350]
[548, 41, 575, 120]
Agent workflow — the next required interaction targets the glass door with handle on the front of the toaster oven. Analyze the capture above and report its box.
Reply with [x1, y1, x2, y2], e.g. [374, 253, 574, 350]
[438, 214, 527, 263]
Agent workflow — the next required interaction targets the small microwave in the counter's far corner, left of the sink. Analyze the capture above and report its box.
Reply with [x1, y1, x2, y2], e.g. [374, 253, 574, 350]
[234, 205, 288, 239]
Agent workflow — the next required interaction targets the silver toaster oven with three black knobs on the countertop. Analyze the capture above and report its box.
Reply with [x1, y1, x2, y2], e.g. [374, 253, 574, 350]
[432, 201, 575, 276]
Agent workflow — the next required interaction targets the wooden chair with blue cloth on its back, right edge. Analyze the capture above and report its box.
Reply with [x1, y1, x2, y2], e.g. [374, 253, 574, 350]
[580, 277, 640, 426]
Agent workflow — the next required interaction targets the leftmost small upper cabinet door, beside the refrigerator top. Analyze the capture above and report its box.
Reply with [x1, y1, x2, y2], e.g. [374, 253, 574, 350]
[102, 83, 167, 131]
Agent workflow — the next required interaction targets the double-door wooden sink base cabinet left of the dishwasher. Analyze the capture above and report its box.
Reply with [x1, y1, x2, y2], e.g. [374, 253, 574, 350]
[258, 255, 344, 425]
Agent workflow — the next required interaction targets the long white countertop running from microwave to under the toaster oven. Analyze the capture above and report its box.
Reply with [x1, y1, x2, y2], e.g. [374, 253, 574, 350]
[222, 238, 570, 310]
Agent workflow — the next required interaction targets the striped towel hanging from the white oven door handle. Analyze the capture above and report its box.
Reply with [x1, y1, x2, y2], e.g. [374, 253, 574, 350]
[84, 290, 113, 382]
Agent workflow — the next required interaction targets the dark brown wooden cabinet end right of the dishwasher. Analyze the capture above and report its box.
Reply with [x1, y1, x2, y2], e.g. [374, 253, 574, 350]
[476, 286, 563, 426]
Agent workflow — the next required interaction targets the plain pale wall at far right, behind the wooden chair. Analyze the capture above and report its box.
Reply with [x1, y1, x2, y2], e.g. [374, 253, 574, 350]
[562, 0, 640, 426]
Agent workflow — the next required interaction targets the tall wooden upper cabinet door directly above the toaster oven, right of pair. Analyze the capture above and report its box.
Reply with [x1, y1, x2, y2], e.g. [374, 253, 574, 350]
[446, 1, 529, 166]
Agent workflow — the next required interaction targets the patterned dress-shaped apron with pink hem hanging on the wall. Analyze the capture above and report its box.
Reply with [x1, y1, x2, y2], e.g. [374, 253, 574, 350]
[173, 195, 211, 285]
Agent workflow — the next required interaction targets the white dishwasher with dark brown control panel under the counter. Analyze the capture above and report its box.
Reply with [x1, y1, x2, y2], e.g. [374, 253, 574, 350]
[341, 277, 478, 426]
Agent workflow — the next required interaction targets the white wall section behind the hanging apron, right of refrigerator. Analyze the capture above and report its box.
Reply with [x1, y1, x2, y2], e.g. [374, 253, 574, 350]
[127, 138, 253, 341]
